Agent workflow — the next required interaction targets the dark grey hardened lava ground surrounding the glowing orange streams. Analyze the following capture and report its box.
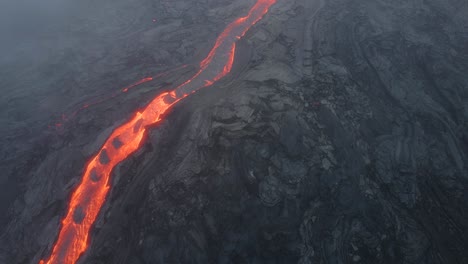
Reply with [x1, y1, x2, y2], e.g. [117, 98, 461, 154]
[0, 0, 468, 264]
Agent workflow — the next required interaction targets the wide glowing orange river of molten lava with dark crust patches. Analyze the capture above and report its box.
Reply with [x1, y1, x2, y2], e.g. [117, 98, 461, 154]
[40, 0, 276, 264]
